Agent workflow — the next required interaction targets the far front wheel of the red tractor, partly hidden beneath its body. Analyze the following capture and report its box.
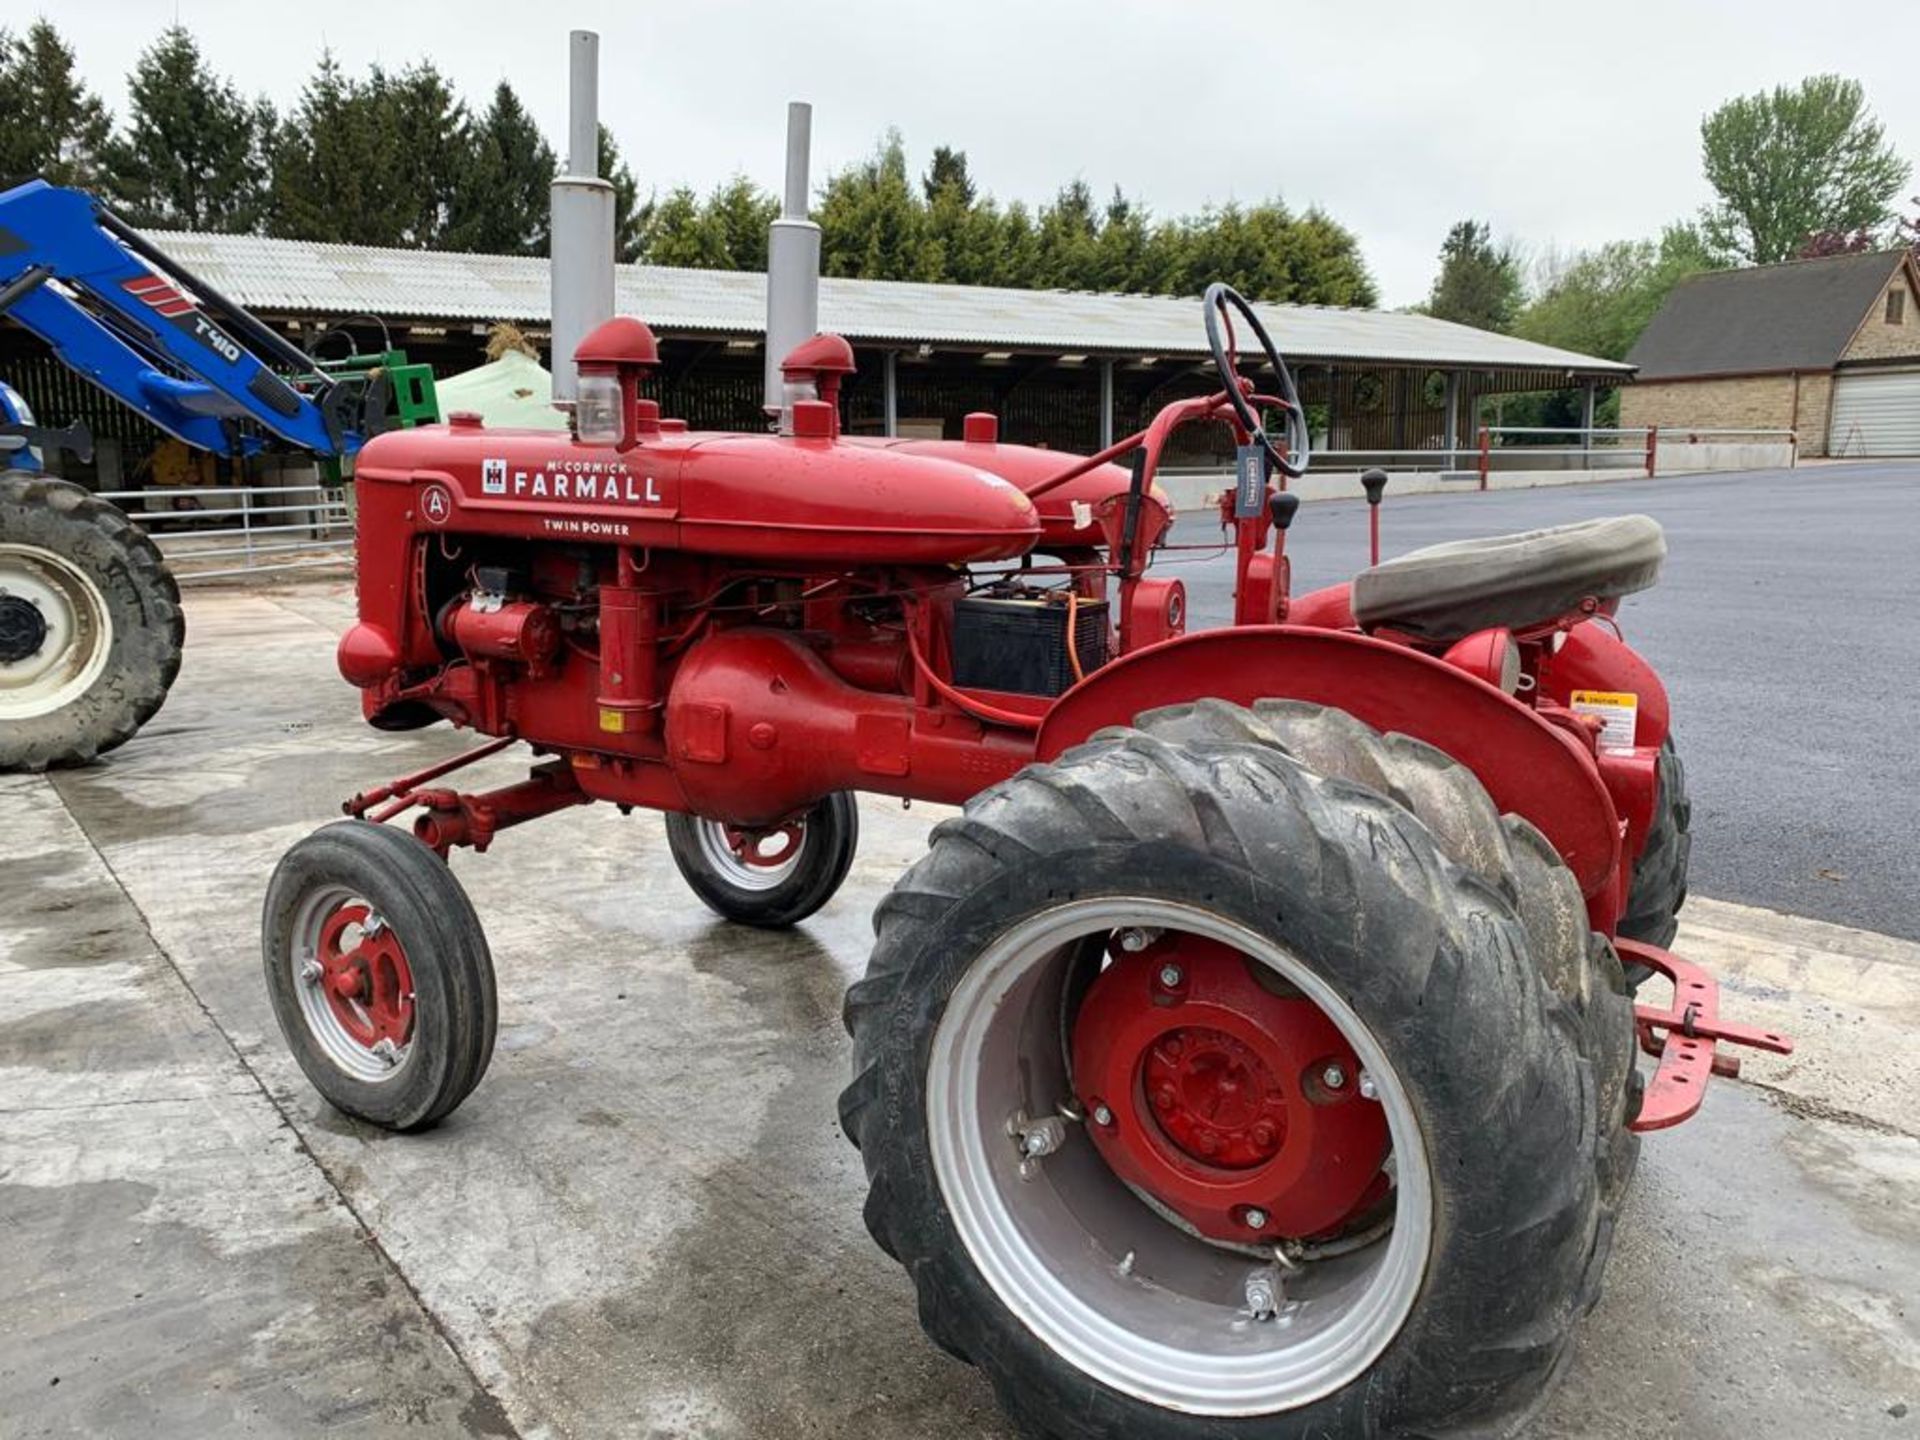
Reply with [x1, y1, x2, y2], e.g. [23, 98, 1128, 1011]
[666, 791, 860, 929]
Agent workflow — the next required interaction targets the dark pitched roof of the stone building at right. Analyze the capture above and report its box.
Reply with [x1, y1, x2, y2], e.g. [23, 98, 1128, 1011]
[1626, 250, 1907, 380]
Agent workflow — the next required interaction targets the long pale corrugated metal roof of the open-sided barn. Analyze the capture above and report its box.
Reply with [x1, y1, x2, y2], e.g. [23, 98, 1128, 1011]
[148, 230, 1630, 374]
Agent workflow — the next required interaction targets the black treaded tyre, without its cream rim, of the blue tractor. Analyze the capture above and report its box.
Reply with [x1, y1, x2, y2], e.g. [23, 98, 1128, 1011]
[0, 470, 186, 772]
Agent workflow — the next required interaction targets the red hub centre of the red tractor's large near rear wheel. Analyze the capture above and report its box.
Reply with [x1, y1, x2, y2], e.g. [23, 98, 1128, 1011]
[1073, 935, 1388, 1242]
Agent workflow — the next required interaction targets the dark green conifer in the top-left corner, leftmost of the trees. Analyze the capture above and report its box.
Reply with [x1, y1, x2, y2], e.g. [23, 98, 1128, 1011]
[0, 19, 111, 188]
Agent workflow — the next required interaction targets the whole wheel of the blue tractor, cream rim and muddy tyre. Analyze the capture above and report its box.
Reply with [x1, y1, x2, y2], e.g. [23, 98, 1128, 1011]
[0, 470, 186, 770]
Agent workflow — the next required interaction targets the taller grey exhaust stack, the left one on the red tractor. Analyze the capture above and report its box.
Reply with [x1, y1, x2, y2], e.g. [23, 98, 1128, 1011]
[549, 31, 612, 409]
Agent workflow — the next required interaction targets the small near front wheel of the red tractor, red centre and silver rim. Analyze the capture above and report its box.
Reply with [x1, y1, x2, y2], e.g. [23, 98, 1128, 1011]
[261, 820, 499, 1131]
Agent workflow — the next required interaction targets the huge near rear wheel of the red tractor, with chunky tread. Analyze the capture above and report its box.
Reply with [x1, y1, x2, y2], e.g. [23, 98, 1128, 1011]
[841, 707, 1630, 1440]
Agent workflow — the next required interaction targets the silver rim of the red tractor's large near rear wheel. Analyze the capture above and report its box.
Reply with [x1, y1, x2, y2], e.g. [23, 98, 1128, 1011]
[925, 897, 1432, 1417]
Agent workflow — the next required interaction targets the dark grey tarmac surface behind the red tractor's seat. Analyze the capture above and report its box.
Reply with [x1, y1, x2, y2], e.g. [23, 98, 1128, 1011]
[1169, 463, 1920, 939]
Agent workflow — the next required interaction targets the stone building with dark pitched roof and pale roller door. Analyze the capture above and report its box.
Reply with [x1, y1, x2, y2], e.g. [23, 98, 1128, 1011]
[1620, 250, 1920, 457]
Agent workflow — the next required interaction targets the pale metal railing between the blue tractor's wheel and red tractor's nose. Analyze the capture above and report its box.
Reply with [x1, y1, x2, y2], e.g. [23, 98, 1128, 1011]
[100, 484, 353, 582]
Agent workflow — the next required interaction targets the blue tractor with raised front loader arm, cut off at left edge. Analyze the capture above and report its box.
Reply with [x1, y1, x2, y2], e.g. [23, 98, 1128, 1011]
[0, 180, 438, 772]
